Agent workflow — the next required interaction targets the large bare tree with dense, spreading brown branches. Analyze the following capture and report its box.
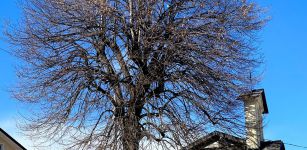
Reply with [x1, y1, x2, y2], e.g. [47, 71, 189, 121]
[6, 0, 265, 150]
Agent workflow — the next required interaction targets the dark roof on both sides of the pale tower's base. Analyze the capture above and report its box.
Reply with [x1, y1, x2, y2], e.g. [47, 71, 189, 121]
[183, 131, 285, 150]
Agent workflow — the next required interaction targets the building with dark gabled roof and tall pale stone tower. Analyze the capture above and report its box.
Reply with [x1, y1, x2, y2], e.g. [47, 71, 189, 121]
[184, 89, 285, 150]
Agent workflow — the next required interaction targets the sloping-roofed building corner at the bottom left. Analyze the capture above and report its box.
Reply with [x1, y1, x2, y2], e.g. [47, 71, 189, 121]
[0, 128, 27, 150]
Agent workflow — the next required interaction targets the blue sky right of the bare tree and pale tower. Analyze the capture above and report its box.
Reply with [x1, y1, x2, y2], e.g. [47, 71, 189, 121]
[259, 0, 307, 150]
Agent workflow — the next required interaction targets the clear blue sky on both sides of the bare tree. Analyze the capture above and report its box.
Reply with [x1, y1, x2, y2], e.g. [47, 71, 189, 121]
[0, 0, 307, 150]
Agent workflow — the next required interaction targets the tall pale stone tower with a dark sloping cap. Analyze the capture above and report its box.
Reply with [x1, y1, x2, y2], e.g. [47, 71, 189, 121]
[240, 89, 268, 149]
